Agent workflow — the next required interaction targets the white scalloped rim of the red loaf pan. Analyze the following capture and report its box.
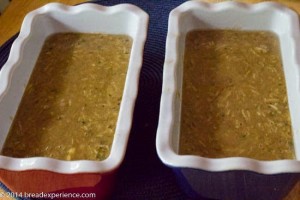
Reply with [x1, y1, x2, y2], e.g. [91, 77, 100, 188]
[0, 3, 149, 174]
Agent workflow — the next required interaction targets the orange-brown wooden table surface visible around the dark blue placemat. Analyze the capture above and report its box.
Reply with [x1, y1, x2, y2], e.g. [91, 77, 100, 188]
[0, 0, 300, 200]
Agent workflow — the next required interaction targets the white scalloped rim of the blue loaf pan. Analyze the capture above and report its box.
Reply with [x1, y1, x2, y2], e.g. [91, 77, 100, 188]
[156, 1, 300, 174]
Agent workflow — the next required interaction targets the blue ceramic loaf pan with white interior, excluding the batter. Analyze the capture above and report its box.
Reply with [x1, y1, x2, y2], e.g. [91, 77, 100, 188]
[156, 1, 300, 200]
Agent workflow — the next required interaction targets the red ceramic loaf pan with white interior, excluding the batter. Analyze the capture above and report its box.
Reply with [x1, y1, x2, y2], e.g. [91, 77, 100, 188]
[0, 3, 149, 199]
